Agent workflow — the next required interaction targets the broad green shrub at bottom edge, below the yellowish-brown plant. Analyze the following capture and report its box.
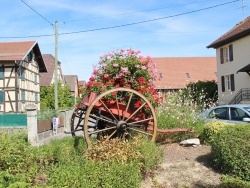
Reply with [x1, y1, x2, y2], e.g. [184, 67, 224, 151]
[47, 160, 141, 188]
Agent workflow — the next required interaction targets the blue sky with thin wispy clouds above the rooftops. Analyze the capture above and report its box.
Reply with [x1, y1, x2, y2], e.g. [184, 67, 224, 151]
[0, 0, 250, 81]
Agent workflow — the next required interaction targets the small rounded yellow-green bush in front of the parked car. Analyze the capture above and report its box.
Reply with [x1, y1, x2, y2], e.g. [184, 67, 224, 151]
[199, 121, 230, 144]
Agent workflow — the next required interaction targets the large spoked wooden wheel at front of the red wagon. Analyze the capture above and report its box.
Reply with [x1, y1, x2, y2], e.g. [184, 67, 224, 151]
[84, 88, 157, 147]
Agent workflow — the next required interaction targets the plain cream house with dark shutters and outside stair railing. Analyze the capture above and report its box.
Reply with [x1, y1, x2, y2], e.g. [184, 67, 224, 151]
[207, 17, 250, 104]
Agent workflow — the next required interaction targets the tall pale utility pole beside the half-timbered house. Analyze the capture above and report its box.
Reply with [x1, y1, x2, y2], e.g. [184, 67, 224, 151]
[54, 21, 58, 112]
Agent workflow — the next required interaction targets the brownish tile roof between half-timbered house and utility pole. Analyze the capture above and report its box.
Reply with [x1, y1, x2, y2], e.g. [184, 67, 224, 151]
[40, 54, 62, 86]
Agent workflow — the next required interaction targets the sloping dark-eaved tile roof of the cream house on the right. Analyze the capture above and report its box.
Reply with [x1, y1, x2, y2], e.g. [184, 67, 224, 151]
[207, 17, 250, 48]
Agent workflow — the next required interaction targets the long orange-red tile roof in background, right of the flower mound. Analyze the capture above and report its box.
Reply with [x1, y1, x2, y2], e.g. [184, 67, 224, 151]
[152, 57, 217, 89]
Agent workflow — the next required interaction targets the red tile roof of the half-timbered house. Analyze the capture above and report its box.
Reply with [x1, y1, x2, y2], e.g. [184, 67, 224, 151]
[0, 41, 47, 72]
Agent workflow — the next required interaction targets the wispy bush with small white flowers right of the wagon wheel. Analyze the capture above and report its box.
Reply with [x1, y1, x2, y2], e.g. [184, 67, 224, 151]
[156, 91, 205, 142]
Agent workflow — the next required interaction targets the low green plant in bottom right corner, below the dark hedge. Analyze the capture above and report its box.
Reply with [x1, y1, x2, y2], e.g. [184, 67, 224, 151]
[220, 176, 250, 188]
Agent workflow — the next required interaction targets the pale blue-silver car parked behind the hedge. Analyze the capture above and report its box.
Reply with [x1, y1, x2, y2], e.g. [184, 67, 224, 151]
[200, 104, 250, 124]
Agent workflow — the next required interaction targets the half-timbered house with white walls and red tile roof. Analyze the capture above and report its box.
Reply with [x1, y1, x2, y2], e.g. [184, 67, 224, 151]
[0, 41, 47, 112]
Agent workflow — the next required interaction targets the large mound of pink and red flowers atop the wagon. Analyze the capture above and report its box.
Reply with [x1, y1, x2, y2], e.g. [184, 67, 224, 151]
[84, 49, 160, 108]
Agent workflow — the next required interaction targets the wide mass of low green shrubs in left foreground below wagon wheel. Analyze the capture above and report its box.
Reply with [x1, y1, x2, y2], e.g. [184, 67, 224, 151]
[0, 132, 161, 188]
